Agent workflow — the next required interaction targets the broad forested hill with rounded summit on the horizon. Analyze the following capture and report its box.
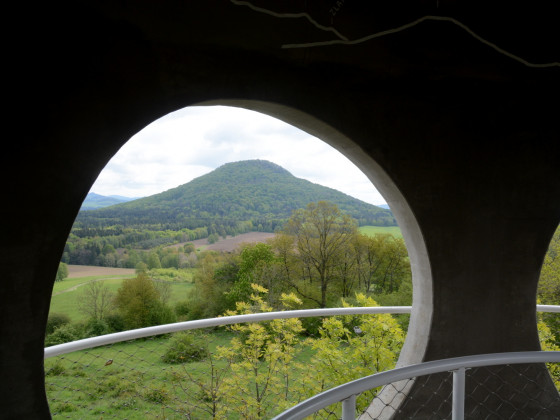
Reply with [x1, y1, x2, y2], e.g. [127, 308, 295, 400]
[74, 160, 395, 234]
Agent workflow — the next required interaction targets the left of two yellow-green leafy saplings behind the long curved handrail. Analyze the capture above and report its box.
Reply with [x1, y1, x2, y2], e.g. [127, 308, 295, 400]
[217, 284, 316, 419]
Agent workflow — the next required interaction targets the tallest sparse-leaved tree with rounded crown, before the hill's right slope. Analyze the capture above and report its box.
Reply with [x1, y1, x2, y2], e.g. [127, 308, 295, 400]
[283, 201, 357, 308]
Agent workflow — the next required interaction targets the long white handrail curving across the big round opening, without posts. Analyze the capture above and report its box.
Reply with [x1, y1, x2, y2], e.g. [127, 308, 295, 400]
[44, 306, 412, 359]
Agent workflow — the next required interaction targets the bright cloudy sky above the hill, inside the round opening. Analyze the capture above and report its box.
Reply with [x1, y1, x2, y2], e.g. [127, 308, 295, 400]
[90, 106, 386, 205]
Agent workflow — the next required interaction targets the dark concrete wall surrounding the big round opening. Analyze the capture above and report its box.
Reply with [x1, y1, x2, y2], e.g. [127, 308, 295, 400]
[0, 1, 560, 419]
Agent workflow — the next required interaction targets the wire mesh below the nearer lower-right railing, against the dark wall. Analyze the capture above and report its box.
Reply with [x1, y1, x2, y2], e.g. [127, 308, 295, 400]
[359, 363, 560, 420]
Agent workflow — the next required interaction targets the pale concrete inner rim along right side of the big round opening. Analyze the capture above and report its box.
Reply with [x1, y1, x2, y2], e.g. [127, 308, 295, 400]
[47, 101, 431, 416]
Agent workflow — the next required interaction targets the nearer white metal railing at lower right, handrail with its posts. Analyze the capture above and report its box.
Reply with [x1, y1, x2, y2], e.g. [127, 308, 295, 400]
[273, 351, 560, 420]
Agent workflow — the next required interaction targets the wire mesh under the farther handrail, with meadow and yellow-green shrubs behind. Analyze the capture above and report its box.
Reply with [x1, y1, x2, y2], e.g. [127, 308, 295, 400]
[45, 314, 404, 419]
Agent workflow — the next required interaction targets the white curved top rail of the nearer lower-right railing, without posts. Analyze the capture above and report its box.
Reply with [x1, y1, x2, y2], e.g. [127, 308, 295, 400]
[273, 351, 560, 420]
